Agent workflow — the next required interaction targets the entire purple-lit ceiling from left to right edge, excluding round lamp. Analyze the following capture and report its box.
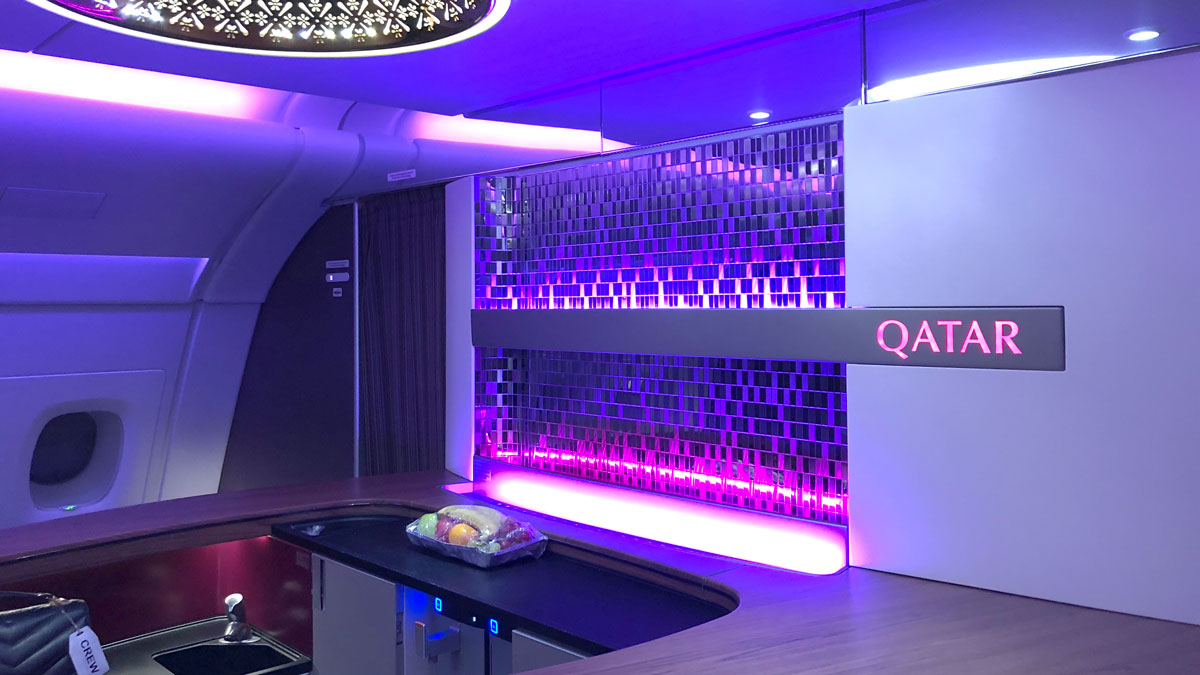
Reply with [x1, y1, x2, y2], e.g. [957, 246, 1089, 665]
[0, 0, 1200, 144]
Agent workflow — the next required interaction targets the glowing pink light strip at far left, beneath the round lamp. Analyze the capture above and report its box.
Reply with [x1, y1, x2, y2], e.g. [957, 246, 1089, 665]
[0, 49, 276, 119]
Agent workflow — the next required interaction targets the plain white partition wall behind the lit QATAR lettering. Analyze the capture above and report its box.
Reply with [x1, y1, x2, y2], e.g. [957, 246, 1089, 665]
[846, 52, 1200, 623]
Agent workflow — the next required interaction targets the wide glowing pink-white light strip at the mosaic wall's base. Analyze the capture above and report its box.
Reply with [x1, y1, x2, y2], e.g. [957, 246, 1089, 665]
[475, 472, 847, 574]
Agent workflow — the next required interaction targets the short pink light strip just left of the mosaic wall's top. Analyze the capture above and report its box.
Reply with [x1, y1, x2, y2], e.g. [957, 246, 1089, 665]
[410, 113, 630, 153]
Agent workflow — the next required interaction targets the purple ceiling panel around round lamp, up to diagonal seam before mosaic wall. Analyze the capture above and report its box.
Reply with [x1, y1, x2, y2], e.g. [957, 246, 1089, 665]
[7, 0, 884, 114]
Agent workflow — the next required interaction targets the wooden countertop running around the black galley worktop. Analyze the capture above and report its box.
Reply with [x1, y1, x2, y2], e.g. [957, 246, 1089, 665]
[0, 472, 1200, 675]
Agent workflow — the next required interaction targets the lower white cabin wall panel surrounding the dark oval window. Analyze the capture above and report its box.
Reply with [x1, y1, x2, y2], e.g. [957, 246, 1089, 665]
[0, 305, 191, 527]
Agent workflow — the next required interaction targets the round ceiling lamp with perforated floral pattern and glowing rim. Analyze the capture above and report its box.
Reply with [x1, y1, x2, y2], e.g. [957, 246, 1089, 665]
[29, 0, 511, 56]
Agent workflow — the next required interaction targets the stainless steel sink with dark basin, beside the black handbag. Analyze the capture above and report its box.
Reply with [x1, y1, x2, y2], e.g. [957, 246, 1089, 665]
[104, 616, 312, 675]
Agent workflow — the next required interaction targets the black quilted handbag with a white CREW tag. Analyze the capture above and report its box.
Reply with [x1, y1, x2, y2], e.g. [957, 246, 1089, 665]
[0, 591, 89, 675]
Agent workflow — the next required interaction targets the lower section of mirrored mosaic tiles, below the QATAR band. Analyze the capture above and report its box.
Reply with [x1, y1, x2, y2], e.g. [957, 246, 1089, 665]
[475, 347, 846, 524]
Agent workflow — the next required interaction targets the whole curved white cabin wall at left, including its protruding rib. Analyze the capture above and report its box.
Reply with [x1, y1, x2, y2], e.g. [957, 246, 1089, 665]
[0, 70, 595, 527]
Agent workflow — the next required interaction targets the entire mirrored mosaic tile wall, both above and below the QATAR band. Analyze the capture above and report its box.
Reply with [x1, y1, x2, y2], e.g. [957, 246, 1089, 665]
[475, 121, 848, 525]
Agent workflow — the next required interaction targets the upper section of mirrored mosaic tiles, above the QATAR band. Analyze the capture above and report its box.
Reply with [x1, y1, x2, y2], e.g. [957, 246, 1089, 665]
[475, 121, 846, 309]
